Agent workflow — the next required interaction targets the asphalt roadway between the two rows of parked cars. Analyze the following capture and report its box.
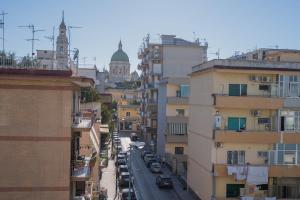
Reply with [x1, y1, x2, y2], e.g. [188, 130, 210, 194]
[119, 133, 179, 200]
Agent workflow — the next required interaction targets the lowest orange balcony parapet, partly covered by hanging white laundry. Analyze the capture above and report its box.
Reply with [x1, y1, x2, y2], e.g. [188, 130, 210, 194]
[214, 164, 300, 177]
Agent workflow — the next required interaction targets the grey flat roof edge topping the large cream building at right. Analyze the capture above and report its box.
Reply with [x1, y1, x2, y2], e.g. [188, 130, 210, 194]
[192, 59, 300, 73]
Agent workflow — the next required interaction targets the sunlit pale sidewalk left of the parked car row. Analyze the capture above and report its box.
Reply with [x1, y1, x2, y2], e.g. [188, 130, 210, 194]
[100, 145, 116, 200]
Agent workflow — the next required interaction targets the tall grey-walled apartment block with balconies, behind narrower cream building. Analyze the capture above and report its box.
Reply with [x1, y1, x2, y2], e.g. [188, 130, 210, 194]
[138, 35, 207, 151]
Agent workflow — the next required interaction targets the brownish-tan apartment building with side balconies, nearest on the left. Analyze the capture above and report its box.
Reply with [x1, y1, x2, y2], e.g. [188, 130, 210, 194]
[0, 58, 99, 200]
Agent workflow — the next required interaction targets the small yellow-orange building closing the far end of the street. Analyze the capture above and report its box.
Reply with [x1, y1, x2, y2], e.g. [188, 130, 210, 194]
[118, 99, 141, 132]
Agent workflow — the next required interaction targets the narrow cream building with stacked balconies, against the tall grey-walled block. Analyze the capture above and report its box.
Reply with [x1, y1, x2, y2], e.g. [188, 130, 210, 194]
[157, 77, 190, 174]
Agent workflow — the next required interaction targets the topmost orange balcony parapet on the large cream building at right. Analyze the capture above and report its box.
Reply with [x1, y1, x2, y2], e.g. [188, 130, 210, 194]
[213, 94, 283, 110]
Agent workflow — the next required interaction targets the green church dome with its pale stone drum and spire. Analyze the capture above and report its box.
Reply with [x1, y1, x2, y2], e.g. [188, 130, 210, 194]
[109, 41, 131, 83]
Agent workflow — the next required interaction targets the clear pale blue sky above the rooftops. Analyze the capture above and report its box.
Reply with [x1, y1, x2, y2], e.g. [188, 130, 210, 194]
[0, 0, 300, 71]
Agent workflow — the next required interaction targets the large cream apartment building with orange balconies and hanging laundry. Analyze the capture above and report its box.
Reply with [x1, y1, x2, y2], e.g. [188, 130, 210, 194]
[188, 59, 300, 199]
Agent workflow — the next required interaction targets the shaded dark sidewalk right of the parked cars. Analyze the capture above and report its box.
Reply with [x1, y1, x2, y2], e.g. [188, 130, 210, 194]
[162, 166, 197, 200]
